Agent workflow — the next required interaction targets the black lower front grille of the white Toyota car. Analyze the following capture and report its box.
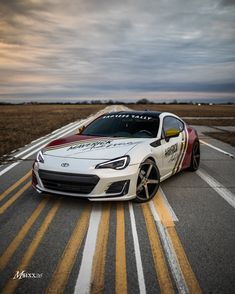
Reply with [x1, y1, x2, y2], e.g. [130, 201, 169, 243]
[38, 170, 99, 194]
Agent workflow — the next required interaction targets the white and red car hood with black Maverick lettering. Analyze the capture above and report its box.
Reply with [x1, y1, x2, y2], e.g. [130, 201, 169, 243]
[43, 135, 146, 159]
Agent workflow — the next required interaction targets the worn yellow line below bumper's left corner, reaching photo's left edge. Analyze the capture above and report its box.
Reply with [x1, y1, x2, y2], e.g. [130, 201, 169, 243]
[0, 198, 48, 271]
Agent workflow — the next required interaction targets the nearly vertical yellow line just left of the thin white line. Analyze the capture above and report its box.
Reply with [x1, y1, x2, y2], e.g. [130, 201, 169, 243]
[116, 202, 127, 294]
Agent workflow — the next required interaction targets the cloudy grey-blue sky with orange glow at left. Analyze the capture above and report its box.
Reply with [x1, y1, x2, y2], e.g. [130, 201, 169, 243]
[0, 0, 235, 101]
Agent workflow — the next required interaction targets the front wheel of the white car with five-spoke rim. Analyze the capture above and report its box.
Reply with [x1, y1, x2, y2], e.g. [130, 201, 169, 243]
[134, 159, 160, 203]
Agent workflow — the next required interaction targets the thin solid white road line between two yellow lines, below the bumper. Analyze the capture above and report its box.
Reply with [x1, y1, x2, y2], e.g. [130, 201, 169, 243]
[129, 202, 146, 294]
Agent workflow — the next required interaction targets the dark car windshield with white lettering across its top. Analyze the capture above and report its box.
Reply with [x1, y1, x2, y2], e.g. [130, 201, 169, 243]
[82, 114, 159, 138]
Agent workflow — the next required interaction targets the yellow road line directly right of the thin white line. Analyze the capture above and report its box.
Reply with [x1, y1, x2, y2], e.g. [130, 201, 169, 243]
[142, 204, 174, 294]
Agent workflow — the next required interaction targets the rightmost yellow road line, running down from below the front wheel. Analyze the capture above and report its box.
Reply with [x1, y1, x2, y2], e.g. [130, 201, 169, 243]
[153, 192, 202, 294]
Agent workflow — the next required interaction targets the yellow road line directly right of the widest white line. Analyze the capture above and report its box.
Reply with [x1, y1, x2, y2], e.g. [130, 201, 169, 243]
[91, 203, 110, 294]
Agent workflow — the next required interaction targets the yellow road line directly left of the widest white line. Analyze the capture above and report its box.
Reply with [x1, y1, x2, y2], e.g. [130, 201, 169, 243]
[47, 204, 91, 294]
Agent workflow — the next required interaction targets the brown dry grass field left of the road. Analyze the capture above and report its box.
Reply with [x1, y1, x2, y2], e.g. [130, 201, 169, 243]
[0, 105, 104, 156]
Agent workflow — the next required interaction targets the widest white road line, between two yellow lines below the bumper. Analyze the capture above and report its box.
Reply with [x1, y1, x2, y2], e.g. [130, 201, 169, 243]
[74, 204, 102, 294]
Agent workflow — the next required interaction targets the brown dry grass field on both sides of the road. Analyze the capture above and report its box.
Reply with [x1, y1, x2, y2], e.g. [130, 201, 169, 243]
[0, 104, 235, 156]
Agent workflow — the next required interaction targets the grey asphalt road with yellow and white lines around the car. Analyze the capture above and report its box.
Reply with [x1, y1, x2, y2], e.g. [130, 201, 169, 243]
[0, 107, 235, 294]
